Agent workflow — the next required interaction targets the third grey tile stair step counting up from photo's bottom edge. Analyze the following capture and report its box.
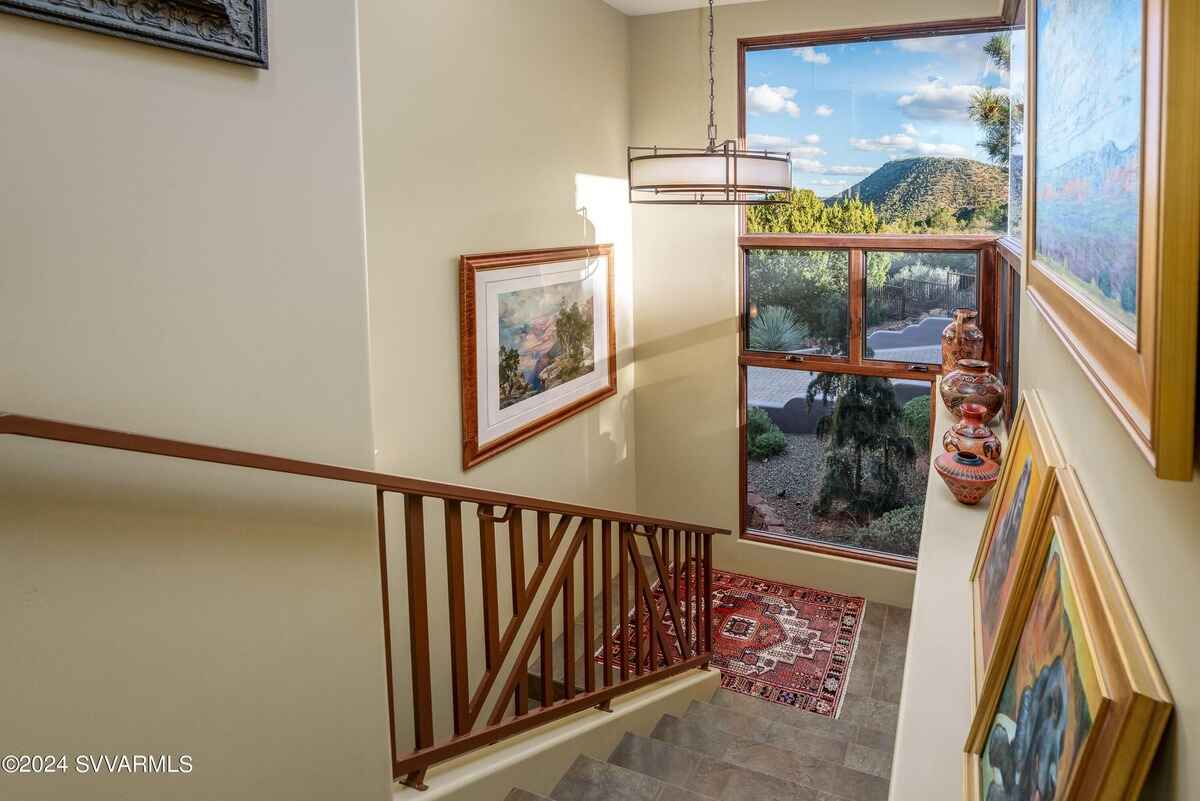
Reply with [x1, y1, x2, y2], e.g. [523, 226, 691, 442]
[608, 734, 828, 801]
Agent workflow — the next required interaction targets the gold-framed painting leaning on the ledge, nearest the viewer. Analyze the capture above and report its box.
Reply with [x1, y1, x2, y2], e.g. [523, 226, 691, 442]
[965, 468, 1172, 801]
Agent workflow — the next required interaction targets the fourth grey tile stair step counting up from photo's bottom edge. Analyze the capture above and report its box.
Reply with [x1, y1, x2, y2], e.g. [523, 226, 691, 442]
[650, 715, 888, 801]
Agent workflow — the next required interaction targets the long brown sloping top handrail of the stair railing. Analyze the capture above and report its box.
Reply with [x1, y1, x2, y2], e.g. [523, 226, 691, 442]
[0, 412, 731, 535]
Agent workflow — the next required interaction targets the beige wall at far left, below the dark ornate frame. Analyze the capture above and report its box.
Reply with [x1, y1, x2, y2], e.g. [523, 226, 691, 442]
[0, 2, 389, 801]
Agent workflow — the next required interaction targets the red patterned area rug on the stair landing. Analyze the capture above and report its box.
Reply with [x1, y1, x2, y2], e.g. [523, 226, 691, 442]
[595, 570, 864, 717]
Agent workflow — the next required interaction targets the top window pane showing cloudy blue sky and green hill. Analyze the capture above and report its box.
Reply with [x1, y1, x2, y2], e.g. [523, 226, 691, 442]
[742, 31, 1024, 234]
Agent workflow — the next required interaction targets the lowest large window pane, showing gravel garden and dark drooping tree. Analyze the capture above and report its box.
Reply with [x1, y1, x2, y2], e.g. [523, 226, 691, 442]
[745, 367, 930, 560]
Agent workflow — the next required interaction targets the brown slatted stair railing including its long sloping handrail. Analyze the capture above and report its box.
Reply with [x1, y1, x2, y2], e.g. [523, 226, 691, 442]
[0, 414, 730, 789]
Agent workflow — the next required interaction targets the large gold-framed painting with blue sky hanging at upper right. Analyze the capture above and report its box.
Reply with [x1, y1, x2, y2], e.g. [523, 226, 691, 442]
[1026, 0, 1200, 481]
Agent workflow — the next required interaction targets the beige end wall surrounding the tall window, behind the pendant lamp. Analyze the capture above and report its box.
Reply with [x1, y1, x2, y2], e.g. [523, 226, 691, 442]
[631, 0, 998, 606]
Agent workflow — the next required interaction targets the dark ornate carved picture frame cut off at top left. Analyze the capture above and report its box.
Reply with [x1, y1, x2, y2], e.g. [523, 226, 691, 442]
[0, 0, 268, 70]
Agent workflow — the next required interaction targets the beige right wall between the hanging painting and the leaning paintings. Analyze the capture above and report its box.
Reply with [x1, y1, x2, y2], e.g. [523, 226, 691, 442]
[1021, 297, 1200, 801]
